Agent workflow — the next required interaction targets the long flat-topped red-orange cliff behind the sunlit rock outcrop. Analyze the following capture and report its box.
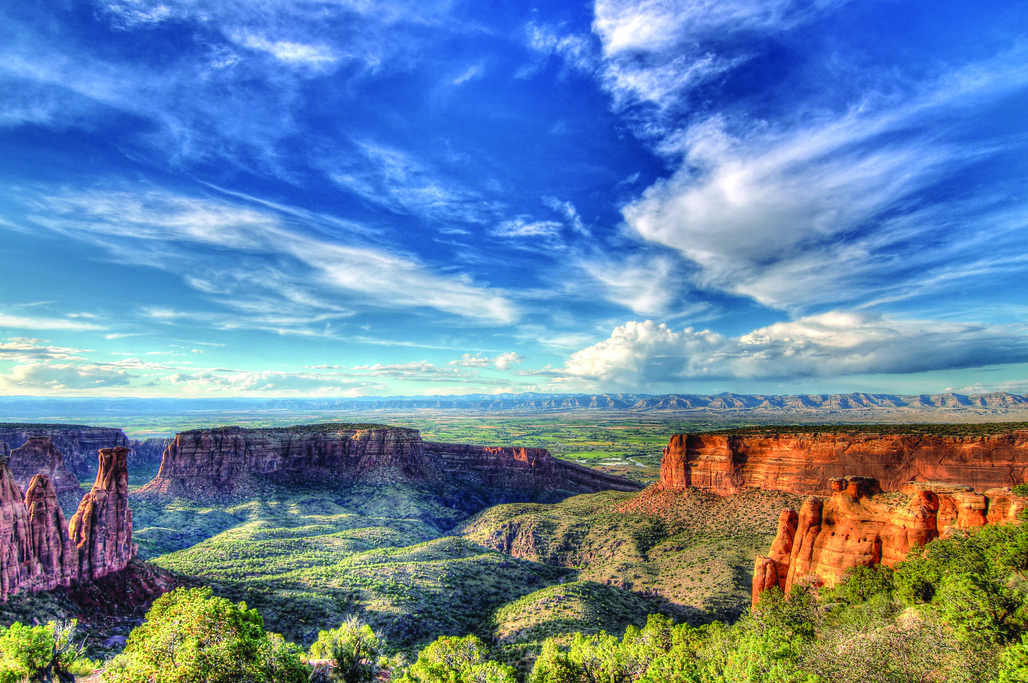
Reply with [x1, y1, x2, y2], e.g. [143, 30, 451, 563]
[660, 431, 1028, 495]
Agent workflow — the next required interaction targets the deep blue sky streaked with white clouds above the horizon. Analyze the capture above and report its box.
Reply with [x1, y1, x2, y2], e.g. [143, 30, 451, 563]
[0, 0, 1028, 397]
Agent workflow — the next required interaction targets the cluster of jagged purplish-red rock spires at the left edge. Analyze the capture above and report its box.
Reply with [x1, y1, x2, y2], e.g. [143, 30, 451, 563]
[0, 448, 136, 601]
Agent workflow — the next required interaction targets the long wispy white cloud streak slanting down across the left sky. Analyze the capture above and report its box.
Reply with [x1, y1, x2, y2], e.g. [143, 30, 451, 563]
[29, 191, 517, 325]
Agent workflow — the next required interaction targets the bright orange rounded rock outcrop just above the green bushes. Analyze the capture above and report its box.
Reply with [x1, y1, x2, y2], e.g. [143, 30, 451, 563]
[752, 476, 1028, 606]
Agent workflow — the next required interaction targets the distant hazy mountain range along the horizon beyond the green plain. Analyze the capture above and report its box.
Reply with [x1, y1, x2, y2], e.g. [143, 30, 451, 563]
[0, 392, 1028, 415]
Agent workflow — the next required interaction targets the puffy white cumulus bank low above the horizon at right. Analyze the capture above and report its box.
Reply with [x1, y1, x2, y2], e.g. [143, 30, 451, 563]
[564, 311, 1028, 391]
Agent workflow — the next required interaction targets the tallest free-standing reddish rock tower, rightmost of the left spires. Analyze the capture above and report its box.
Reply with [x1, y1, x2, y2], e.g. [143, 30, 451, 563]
[68, 448, 137, 581]
